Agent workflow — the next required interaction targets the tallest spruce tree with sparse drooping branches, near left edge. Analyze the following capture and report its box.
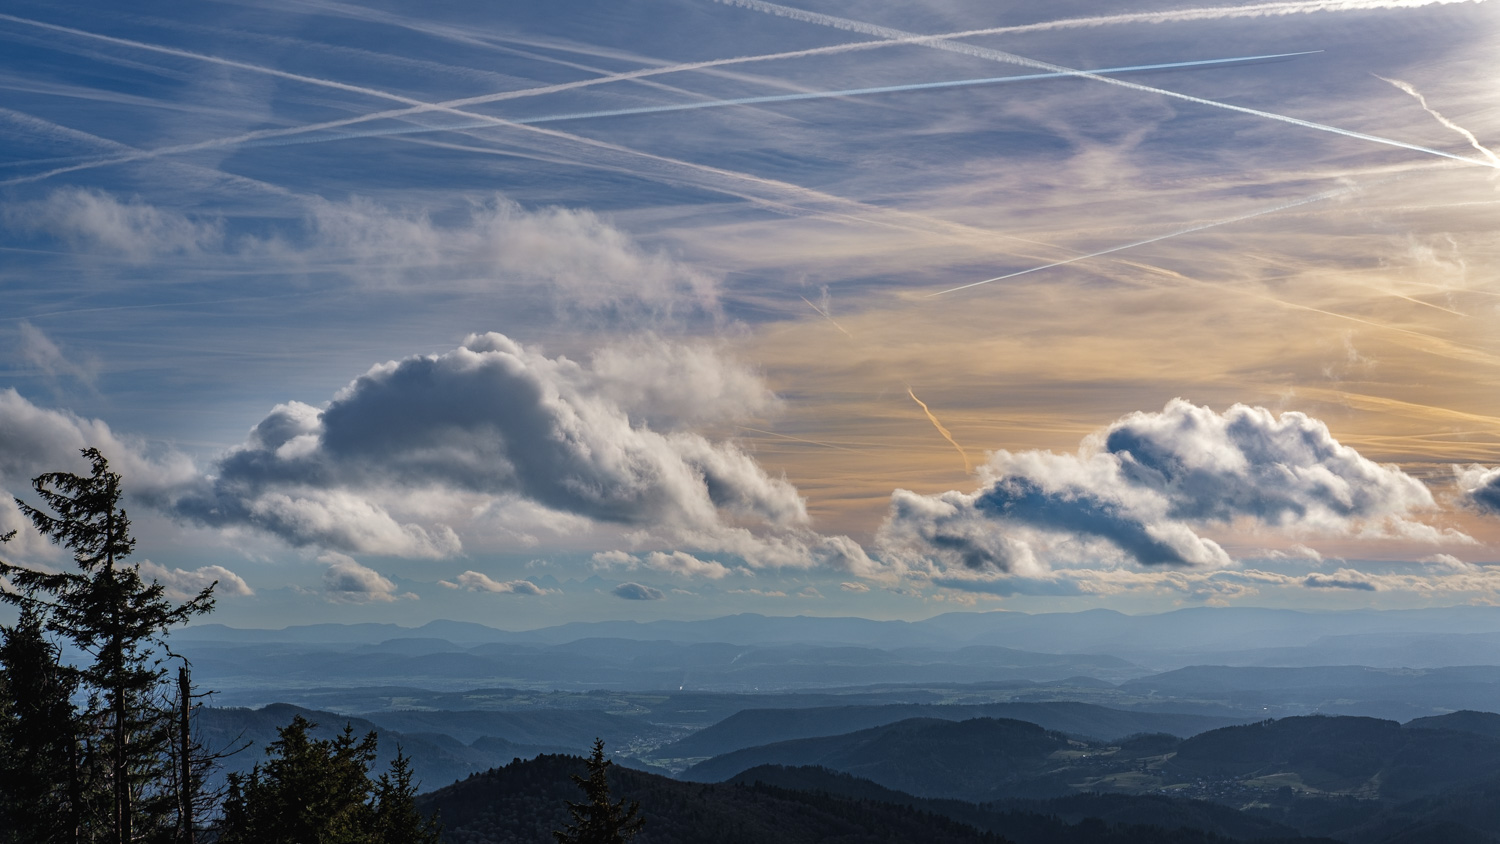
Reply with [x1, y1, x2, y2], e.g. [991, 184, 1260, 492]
[0, 448, 213, 844]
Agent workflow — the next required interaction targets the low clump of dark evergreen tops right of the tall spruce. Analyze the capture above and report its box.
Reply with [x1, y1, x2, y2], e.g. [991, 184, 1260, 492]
[218, 715, 438, 844]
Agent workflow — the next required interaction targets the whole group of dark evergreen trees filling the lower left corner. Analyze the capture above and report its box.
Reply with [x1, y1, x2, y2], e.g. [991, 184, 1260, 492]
[0, 448, 438, 844]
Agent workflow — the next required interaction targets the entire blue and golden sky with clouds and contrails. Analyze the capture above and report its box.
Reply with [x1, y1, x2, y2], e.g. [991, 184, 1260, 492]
[0, 0, 1500, 630]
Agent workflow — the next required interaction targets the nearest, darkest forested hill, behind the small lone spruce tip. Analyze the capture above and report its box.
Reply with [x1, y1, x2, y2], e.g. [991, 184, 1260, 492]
[419, 756, 1332, 844]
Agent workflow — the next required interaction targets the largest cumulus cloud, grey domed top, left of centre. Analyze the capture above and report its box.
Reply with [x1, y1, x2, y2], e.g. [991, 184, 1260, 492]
[177, 334, 834, 563]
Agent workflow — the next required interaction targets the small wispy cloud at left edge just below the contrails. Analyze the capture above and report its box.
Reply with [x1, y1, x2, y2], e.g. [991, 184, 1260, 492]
[5, 187, 224, 261]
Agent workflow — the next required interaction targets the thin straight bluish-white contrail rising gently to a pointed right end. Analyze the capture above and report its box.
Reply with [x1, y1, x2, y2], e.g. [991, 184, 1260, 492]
[264, 49, 1322, 147]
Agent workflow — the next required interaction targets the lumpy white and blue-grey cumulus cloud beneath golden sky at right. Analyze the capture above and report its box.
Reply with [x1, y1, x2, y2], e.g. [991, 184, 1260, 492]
[878, 399, 1440, 594]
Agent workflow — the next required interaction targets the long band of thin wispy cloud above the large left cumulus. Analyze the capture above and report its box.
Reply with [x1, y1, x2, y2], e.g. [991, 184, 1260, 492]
[3, 187, 720, 321]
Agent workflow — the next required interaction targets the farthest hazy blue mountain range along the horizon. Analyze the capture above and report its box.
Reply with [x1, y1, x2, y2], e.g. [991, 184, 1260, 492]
[173, 606, 1500, 656]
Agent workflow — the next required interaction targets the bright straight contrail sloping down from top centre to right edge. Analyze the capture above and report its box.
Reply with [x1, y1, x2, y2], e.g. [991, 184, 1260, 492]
[716, 0, 1500, 169]
